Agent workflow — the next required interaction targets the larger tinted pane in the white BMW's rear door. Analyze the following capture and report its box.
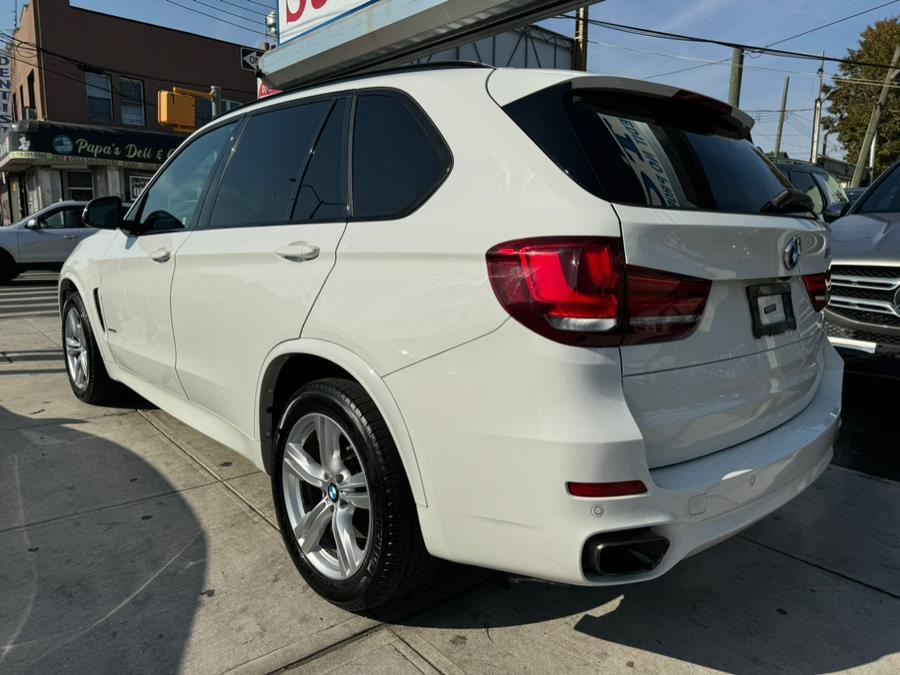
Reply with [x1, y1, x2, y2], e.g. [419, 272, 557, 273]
[210, 100, 332, 227]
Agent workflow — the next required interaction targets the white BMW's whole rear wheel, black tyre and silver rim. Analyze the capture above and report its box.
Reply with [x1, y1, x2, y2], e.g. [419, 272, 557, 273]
[272, 379, 434, 611]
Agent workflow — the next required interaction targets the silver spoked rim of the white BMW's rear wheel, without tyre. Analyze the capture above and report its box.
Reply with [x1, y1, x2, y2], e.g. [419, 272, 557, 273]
[282, 413, 372, 580]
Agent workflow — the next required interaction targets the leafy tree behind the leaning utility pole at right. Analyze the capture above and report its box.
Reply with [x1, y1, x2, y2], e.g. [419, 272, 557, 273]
[822, 17, 900, 175]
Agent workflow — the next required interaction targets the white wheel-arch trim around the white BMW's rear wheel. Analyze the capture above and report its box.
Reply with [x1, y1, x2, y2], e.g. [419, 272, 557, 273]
[256, 338, 427, 506]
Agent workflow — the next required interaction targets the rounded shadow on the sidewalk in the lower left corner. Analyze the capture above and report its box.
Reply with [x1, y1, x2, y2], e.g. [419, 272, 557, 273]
[0, 410, 207, 672]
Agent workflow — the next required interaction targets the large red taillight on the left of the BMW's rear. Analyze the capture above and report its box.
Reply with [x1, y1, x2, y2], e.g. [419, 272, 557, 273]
[487, 237, 710, 347]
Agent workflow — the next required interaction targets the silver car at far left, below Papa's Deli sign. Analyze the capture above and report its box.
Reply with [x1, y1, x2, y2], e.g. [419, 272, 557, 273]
[0, 202, 96, 283]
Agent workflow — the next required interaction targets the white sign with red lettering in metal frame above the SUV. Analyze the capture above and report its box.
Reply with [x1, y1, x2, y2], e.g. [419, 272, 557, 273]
[260, 0, 585, 89]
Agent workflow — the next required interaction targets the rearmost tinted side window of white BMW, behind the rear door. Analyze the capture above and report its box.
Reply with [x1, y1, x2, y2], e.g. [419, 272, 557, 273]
[352, 93, 451, 219]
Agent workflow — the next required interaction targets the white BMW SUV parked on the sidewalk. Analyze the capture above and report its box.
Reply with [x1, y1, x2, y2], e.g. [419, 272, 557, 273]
[59, 67, 842, 610]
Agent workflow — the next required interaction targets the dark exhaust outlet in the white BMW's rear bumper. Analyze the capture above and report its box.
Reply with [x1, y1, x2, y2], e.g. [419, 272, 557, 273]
[582, 528, 669, 576]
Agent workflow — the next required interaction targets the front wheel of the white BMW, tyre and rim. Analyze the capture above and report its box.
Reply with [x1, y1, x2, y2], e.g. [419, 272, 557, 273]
[62, 293, 114, 404]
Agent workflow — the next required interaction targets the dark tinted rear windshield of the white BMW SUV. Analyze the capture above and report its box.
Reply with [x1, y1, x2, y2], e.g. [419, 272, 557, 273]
[504, 84, 790, 213]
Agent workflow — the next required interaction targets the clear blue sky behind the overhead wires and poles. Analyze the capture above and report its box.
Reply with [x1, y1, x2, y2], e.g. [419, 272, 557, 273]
[12, 0, 900, 158]
